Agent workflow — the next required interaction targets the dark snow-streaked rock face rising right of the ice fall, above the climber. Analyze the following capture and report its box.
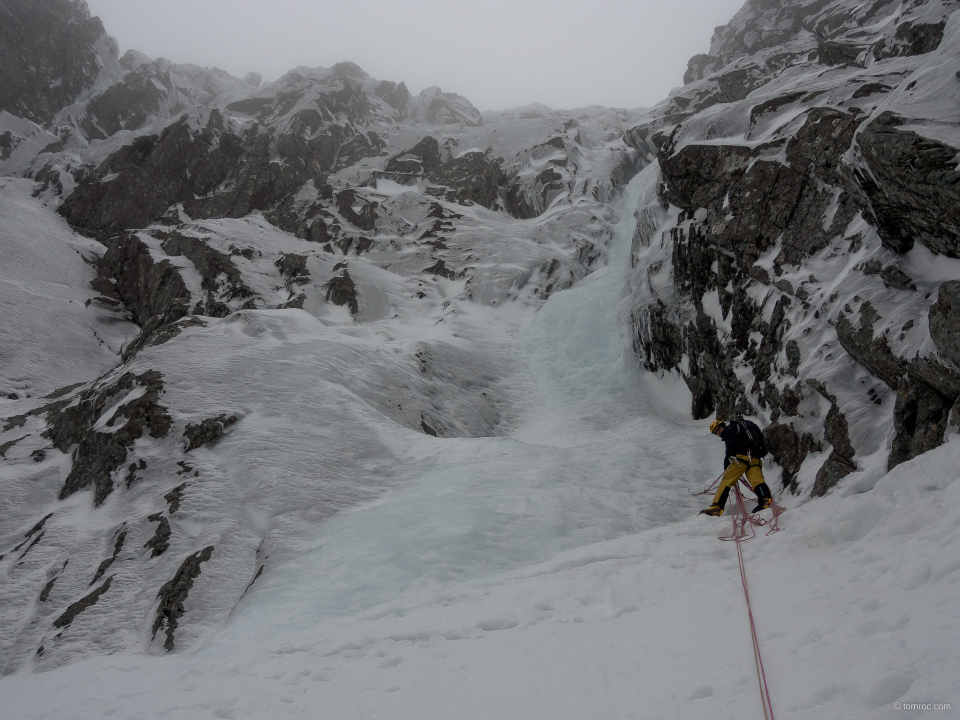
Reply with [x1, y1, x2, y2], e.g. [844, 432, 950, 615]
[627, 0, 960, 495]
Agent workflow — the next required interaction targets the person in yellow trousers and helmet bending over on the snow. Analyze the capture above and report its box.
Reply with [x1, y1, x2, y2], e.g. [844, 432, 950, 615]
[700, 418, 773, 516]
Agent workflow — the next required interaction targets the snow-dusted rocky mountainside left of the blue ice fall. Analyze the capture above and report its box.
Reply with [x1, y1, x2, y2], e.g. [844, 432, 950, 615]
[0, 0, 638, 672]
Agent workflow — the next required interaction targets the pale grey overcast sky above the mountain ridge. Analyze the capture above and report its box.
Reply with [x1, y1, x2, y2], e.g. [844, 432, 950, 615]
[87, 0, 743, 110]
